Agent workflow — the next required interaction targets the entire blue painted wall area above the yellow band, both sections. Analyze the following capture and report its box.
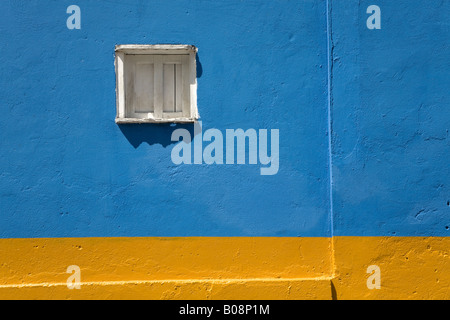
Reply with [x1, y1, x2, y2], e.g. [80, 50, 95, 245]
[0, 0, 450, 238]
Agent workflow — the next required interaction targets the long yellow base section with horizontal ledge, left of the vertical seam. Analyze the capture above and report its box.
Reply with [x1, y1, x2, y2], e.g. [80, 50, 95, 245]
[0, 238, 331, 299]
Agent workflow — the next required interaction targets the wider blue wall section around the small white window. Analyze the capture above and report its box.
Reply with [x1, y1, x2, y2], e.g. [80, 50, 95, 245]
[0, 0, 330, 238]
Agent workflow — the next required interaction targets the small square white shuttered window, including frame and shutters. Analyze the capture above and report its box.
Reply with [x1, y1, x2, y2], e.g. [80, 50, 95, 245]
[115, 45, 198, 124]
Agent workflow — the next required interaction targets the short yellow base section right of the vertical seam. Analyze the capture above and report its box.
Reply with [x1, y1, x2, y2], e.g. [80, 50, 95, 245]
[333, 237, 450, 300]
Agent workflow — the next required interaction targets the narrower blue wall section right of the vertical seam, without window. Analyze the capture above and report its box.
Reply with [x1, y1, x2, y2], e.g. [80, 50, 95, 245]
[332, 0, 450, 236]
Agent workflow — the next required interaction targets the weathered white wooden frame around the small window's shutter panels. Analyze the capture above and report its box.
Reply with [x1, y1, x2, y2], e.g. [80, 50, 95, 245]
[115, 45, 199, 124]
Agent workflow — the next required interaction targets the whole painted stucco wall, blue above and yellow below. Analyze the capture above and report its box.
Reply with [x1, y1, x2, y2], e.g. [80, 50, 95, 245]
[0, 0, 450, 299]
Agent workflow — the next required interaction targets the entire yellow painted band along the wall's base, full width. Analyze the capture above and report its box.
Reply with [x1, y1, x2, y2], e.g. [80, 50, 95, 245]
[0, 237, 450, 300]
